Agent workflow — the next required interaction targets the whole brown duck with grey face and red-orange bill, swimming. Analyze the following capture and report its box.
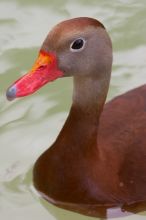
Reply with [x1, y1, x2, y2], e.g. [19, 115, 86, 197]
[7, 18, 146, 216]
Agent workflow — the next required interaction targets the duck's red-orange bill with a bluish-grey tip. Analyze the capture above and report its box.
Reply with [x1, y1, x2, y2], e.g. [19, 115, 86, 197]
[6, 51, 63, 100]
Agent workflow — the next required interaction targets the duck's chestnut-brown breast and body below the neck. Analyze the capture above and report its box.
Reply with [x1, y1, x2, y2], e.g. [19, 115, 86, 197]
[34, 86, 146, 215]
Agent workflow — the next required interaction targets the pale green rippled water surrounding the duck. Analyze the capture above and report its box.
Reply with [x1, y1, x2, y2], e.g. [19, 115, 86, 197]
[0, 0, 146, 220]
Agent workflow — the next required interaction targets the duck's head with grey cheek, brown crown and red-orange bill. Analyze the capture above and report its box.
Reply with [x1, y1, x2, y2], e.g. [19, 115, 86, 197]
[6, 17, 112, 100]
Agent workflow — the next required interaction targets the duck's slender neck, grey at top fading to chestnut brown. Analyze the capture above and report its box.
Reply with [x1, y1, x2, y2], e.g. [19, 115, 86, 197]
[58, 77, 109, 150]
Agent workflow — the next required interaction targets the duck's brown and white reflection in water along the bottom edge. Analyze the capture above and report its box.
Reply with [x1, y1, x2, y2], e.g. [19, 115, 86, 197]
[37, 195, 146, 220]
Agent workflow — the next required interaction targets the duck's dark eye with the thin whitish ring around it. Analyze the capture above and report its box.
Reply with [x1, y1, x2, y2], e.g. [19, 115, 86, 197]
[70, 37, 86, 52]
